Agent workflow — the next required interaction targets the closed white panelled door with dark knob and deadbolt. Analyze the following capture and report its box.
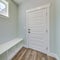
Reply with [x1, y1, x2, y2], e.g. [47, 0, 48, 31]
[27, 7, 49, 52]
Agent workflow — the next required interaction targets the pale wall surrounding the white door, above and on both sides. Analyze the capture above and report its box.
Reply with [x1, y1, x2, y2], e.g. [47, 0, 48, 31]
[19, 0, 55, 52]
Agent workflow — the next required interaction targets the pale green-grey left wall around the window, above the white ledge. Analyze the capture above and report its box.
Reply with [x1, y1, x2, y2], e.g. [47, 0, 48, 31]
[0, 0, 18, 44]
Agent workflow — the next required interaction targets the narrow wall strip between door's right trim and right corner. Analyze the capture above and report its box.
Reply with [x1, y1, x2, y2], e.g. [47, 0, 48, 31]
[49, 0, 55, 53]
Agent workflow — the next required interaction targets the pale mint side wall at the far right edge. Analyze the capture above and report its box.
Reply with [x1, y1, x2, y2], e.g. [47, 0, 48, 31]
[55, 0, 60, 57]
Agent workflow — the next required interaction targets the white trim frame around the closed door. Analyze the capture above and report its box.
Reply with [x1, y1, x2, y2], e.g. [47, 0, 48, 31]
[25, 3, 51, 53]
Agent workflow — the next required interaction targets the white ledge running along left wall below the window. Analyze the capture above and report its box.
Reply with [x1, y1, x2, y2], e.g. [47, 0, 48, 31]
[0, 38, 23, 55]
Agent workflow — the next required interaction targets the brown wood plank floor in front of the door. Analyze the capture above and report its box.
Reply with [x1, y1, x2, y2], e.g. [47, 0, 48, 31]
[12, 47, 56, 60]
